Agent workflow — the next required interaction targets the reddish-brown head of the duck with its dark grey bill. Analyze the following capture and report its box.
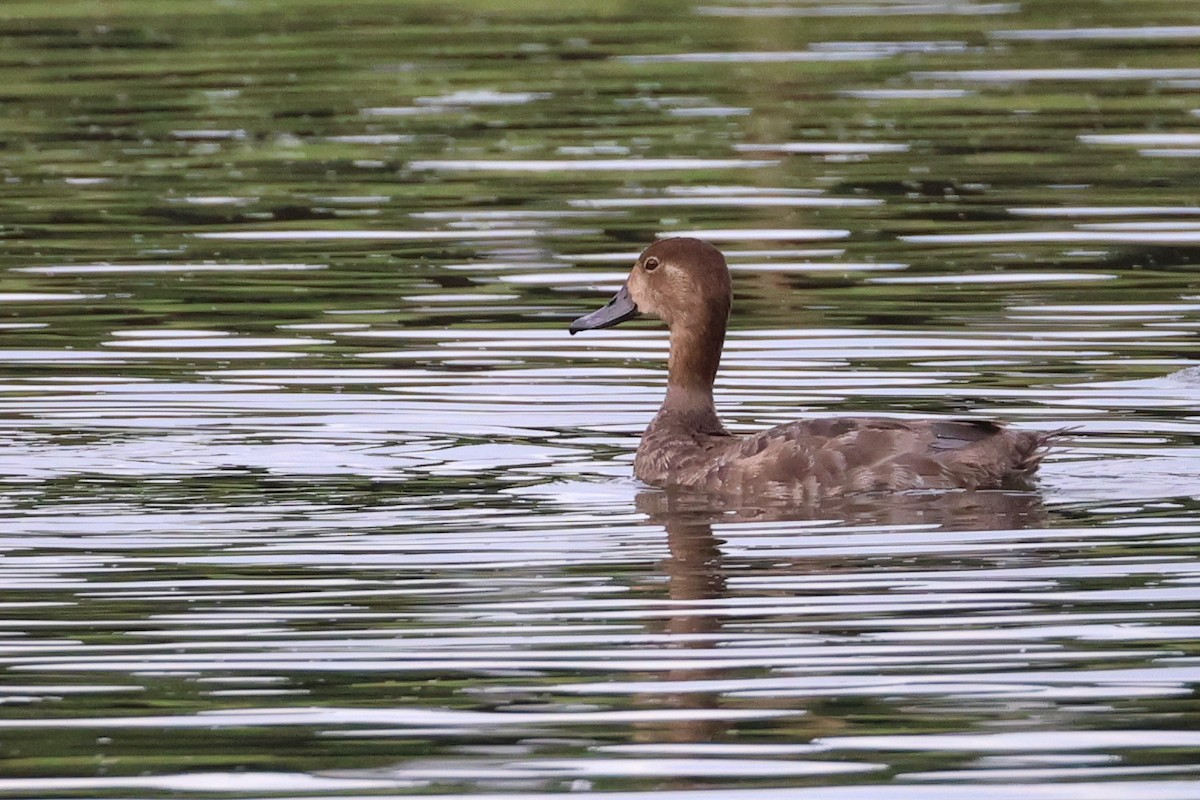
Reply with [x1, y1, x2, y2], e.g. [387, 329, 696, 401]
[569, 237, 732, 337]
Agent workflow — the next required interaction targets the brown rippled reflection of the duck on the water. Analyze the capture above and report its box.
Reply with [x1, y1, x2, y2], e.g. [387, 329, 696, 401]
[636, 488, 1046, 753]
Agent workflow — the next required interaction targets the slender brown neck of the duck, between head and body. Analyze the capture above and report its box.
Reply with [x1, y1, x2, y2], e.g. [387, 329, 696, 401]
[659, 319, 726, 435]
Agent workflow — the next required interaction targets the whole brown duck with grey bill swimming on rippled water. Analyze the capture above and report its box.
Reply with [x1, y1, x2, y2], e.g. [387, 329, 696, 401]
[569, 237, 1054, 503]
